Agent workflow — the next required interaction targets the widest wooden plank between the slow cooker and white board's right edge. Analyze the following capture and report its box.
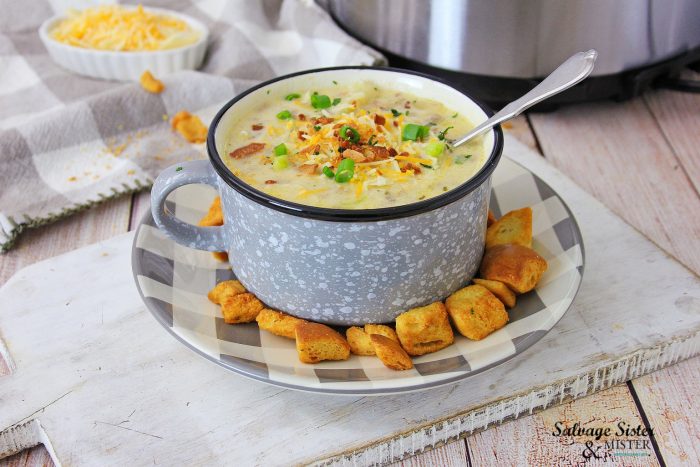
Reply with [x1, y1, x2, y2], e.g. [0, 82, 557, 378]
[530, 98, 700, 273]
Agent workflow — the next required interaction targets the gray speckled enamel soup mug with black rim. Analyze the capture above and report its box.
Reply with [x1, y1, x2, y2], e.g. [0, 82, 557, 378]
[151, 67, 503, 325]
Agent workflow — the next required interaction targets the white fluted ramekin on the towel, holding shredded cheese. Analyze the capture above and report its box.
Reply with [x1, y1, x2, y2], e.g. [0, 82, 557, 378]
[39, 8, 209, 81]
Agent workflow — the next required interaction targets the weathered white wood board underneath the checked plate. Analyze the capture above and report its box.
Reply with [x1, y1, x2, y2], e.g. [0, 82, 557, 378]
[0, 139, 700, 465]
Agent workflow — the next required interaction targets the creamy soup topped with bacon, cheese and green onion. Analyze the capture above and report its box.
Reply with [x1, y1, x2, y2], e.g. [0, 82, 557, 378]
[222, 81, 487, 209]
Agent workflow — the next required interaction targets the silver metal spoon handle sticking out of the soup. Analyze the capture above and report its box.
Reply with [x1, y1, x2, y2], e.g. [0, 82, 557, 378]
[452, 49, 598, 147]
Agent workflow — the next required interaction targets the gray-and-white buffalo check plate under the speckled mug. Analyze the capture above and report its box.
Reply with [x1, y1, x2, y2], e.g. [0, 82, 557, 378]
[132, 157, 584, 395]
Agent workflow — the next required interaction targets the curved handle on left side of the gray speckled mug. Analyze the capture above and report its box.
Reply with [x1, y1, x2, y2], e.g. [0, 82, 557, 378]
[151, 160, 228, 251]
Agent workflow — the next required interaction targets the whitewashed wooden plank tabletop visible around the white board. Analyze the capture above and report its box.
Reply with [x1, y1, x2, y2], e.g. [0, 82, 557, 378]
[0, 81, 700, 467]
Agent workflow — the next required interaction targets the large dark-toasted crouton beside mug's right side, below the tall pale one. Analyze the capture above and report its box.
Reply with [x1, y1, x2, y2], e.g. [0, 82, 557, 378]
[480, 245, 547, 293]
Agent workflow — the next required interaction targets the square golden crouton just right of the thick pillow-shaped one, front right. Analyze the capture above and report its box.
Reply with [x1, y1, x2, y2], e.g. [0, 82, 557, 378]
[445, 285, 508, 341]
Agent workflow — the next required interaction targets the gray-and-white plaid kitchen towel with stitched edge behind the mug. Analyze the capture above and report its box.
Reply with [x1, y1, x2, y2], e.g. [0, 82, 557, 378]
[0, 0, 384, 251]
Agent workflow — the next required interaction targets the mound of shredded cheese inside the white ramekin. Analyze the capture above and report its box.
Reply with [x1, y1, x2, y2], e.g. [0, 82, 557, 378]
[50, 5, 200, 51]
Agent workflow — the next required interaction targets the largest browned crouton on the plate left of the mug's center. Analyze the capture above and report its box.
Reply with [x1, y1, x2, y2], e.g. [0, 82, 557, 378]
[295, 322, 350, 363]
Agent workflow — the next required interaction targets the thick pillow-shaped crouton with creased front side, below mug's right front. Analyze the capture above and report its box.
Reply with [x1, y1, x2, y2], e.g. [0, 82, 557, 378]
[396, 302, 454, 355]
